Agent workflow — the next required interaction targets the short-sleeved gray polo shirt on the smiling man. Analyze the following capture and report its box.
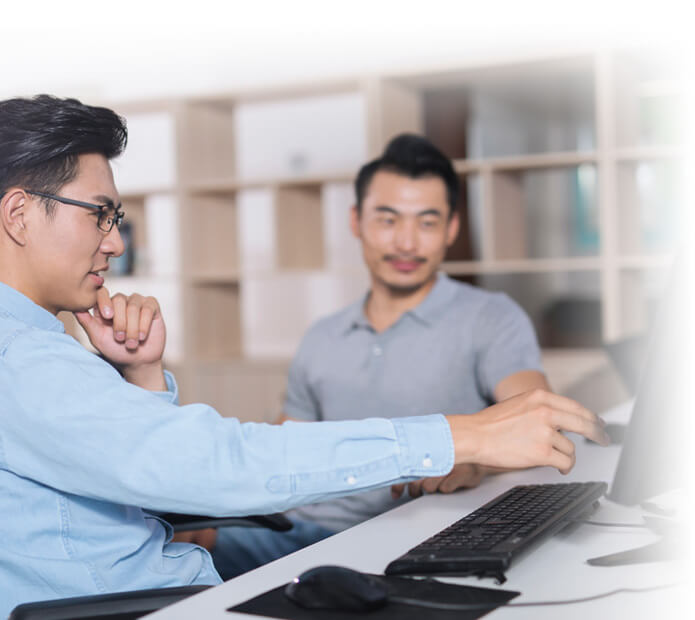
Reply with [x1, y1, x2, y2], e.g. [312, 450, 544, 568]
[284, 274, 542, 531]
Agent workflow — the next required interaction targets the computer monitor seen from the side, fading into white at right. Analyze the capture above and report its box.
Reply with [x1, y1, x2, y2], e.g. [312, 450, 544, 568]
[608, 253, 695, 505]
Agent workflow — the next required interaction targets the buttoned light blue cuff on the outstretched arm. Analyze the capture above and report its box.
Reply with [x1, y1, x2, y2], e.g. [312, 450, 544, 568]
[391, 413, 454, 478]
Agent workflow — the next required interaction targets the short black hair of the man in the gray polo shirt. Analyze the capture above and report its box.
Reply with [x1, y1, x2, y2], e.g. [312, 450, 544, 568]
[355, 133, 459, 217]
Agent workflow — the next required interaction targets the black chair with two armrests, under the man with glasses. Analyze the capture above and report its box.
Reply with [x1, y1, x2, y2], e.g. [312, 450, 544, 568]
[8, 513, 292, 620]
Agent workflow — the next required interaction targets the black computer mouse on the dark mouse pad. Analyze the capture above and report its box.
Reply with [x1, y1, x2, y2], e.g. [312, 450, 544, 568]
[285, 566, 388, 611]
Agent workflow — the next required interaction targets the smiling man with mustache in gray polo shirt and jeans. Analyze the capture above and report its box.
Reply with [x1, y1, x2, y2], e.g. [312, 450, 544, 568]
[213, 135, 549, 576]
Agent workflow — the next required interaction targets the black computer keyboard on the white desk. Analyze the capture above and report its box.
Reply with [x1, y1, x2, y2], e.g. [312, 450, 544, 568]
[385, 482, 607, 583]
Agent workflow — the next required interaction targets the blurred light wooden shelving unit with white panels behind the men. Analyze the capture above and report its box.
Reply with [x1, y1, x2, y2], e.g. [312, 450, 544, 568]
[61, 51, 683, 420]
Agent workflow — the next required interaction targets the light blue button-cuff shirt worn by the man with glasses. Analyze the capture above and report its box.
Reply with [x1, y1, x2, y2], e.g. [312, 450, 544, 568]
[0, 283, 454, 617]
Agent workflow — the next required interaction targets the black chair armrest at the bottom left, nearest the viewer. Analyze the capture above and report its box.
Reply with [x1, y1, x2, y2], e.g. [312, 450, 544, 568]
[8, 586, 210, 620]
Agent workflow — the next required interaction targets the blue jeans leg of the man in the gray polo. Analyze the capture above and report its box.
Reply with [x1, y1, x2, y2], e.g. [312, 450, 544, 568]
[211, 519, 334, 580]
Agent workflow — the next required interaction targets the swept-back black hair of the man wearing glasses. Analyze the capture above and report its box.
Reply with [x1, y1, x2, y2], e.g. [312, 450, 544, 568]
[0, 95, 128, 214]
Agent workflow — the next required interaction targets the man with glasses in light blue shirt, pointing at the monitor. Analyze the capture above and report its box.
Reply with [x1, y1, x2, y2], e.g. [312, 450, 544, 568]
[0, 95, 606, 617]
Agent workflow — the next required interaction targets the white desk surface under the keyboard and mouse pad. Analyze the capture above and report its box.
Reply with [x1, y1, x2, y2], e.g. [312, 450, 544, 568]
[148, 406, 687, 620]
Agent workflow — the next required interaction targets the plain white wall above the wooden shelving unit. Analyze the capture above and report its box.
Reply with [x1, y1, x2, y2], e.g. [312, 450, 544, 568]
[0, 0, 690, 101]
